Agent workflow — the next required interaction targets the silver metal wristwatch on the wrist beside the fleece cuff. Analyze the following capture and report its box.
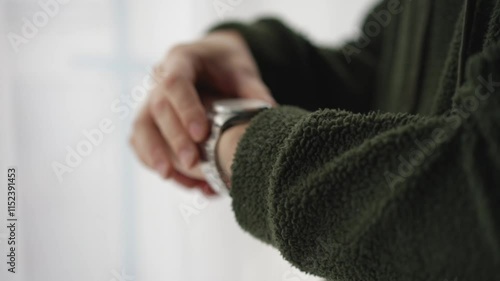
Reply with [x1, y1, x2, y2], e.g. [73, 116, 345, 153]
[201, 99, 271, 194]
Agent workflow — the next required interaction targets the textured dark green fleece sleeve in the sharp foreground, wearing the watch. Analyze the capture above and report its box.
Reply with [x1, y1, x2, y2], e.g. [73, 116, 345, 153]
[231, 44, 500, 281]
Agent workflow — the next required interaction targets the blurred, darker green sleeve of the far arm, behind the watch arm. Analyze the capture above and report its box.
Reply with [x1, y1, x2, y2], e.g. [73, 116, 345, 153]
[212, 1, 388, 112]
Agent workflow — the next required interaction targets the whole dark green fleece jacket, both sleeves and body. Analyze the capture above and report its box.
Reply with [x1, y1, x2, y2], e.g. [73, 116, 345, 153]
[215, 0, 500, 281]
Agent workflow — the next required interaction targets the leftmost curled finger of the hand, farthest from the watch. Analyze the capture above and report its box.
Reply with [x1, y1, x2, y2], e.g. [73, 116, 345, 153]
[130, 109, 173, 178]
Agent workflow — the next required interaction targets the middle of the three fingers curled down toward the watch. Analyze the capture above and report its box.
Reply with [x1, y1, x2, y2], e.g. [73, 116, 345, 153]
[150, 94, 199, 169]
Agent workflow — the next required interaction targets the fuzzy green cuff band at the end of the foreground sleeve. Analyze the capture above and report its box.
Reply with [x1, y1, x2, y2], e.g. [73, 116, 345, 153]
[230, 106, 308, 244]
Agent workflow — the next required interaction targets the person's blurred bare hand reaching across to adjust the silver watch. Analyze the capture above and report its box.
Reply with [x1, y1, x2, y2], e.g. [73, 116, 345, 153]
[131, 31, 275, 192]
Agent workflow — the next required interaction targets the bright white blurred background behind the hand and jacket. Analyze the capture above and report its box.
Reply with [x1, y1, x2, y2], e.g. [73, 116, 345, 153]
[0, 0, 374, 281]
